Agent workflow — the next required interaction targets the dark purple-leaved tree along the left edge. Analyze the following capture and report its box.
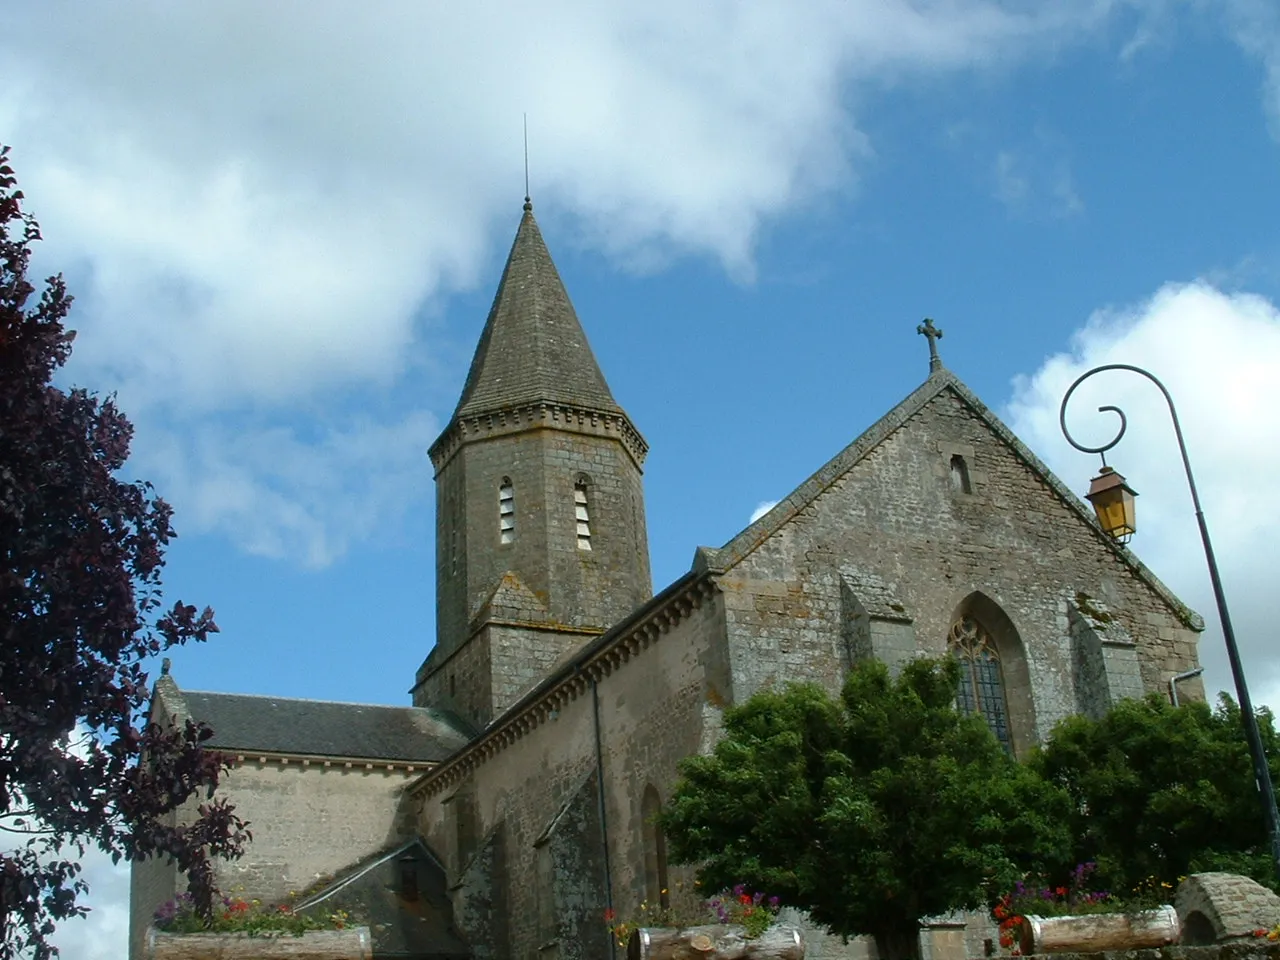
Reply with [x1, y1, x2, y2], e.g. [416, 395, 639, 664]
[0, 147, 247, 960]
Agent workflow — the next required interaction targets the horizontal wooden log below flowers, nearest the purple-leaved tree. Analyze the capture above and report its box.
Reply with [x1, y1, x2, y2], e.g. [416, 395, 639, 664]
[146, 927, 374, 960]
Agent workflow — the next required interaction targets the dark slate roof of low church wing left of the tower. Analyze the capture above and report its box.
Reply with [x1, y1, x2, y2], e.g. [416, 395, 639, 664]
[180, 690, 474, 762]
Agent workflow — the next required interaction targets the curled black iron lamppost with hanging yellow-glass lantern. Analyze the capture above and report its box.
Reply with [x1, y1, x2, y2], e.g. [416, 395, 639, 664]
[1057, 364, 1280, 877]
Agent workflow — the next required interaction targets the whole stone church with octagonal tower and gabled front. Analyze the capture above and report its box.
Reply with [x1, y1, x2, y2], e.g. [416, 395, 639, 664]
[131, 198, 1203, 960]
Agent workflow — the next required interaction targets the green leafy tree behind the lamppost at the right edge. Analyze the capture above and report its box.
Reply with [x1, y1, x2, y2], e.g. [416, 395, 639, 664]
[1034, 694, 1280, 896]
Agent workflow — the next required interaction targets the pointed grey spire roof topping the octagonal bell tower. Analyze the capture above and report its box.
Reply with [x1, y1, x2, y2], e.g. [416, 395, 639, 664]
[453, 197, 622, 419]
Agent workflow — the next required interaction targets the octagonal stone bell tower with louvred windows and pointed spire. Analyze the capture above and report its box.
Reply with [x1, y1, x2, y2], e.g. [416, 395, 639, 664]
[413, 197, 653, 727]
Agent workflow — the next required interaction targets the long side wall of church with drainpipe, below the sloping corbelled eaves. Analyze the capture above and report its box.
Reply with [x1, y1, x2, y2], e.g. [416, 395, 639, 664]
[419, 598, 728, 960]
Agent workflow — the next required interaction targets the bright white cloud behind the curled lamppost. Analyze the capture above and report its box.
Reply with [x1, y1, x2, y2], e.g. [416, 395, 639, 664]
[1006, 283, 1280, 709]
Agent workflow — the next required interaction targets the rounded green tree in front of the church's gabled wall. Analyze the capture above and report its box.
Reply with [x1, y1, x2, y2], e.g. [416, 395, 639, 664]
[660, 658, 1071, 956]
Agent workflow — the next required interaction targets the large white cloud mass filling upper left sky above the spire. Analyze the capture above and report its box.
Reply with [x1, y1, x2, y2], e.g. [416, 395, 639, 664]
[0, 0, 1141, 563]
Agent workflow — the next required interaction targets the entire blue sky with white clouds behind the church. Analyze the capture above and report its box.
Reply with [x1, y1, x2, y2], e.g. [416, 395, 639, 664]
[0, 0, 1280, 956]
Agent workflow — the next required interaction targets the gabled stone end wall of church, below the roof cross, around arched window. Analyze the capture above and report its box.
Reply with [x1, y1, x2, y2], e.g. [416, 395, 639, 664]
[719, 390, 1203, 737]
